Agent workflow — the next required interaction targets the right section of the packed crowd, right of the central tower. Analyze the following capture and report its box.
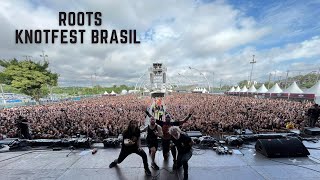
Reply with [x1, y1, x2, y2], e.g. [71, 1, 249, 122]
[166, 94, 312, 135]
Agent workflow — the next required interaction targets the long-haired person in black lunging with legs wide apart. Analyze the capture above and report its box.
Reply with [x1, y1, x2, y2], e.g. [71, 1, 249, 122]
[109, 120, 151, 176]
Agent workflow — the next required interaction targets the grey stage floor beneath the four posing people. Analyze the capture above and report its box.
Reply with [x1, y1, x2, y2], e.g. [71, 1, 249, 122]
[0, 142, 320, 180]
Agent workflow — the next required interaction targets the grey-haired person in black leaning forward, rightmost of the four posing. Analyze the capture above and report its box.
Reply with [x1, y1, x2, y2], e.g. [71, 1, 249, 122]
[169, 126, 193, 179]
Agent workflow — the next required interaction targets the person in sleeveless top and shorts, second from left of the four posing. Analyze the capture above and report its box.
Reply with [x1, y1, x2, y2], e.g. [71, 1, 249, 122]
[142, 117, 163, 170]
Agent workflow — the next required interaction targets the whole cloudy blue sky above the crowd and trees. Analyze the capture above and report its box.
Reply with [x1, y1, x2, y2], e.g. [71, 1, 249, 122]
[0, 0, 320, 86]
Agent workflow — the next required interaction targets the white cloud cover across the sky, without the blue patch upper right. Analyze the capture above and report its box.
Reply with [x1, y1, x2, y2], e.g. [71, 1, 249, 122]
[0, 0, 320, 85]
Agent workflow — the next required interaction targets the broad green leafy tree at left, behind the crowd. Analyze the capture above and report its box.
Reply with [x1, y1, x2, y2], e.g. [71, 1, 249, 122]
[0, 59, 58, 102]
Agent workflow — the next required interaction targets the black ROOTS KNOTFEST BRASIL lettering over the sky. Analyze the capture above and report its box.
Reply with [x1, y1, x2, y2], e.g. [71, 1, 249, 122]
[15, 12, 140, 44]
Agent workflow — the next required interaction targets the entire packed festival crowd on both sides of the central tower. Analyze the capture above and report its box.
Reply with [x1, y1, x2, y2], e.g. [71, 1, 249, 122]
[0, 93, 319, 139]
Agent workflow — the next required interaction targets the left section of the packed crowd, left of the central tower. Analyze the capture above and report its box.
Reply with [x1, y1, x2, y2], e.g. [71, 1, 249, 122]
[0, 95, 149, 139]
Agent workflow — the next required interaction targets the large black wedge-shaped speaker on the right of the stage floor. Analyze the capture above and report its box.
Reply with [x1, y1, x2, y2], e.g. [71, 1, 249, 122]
[255, 138, 310, 157]
